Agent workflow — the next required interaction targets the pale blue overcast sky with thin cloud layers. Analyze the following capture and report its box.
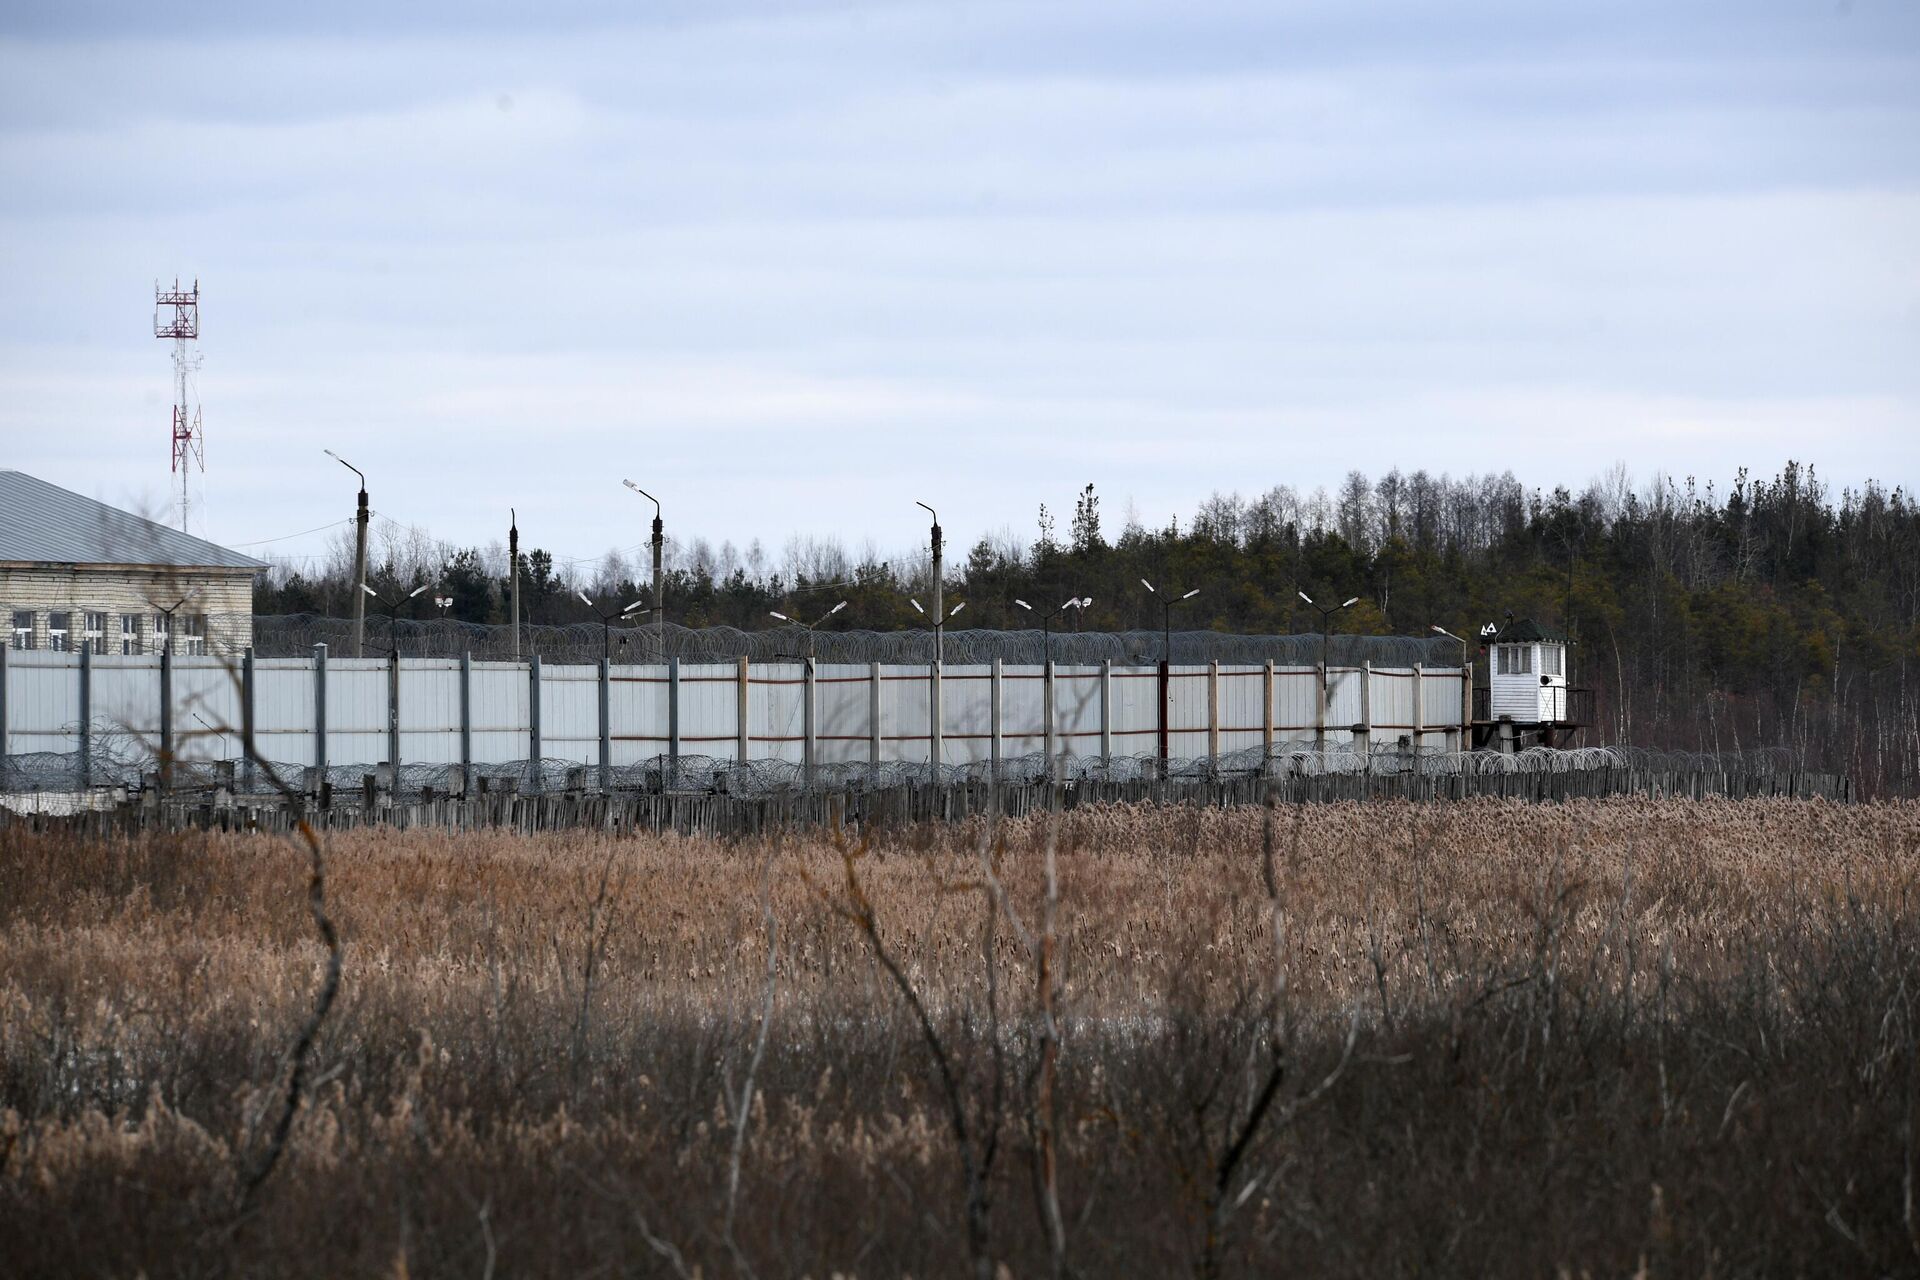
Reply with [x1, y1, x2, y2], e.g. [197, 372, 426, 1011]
[0, 0, 1920, 571]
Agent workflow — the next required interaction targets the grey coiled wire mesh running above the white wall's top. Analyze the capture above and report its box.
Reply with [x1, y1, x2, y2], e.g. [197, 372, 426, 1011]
[236, 614, 1459, 666]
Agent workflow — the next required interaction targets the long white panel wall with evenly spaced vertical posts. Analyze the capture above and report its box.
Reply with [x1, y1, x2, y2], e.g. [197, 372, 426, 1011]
[0, 645, 1471, 790]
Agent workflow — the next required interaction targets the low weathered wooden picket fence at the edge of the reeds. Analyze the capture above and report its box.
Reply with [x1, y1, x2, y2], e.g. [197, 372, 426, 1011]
[0, 768, 1853, 839]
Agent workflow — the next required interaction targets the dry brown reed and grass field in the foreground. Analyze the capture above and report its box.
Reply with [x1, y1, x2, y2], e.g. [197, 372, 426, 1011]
[0, 800, 1920, 1278]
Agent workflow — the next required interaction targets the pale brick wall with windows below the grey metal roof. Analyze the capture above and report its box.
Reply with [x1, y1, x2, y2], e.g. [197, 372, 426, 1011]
[0, 566, 253, 654]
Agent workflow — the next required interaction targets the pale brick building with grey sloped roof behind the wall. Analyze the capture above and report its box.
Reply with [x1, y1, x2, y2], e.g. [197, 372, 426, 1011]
[0, 470, 265, 654]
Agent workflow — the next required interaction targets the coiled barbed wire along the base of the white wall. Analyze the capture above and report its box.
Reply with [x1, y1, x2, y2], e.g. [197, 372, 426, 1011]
[0, 739, 1801, 796]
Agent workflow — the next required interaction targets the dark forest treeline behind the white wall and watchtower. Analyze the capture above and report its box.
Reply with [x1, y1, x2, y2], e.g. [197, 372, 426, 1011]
[255, 464, 1920, 789]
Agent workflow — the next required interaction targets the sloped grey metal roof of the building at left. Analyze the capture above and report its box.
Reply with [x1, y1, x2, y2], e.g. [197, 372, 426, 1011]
[0, 470, 265, 568]
